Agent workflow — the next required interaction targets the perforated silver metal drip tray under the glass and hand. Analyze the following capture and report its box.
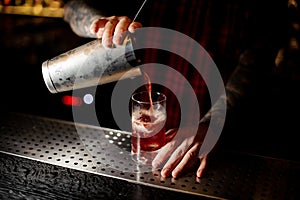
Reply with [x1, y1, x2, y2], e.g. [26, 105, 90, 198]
[0, 113, 300, 200]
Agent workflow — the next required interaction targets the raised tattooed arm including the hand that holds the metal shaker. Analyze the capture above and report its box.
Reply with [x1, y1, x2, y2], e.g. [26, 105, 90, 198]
[64, 0, 142, 46]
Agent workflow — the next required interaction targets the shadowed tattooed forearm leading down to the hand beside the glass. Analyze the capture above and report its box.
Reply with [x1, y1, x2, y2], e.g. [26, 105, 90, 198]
[200, 50, 272, 123]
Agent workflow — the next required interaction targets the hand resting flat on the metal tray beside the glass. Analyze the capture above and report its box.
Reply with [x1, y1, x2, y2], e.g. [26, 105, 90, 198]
[152, 124, 208, 178]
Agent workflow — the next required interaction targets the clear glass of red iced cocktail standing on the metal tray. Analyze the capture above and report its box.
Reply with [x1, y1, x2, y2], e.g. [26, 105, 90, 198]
[131, 91, 166, 164]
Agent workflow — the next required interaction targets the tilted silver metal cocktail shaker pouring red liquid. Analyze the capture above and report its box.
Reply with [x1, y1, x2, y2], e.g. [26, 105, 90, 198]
[42, 36, 141, 93]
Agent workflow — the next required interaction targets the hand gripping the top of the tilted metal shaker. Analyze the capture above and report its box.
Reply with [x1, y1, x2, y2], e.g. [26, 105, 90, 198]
[90, 16, 142, 47]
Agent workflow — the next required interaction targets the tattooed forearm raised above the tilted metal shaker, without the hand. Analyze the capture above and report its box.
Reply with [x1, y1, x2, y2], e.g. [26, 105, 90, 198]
[64, 0, 104, 38]
